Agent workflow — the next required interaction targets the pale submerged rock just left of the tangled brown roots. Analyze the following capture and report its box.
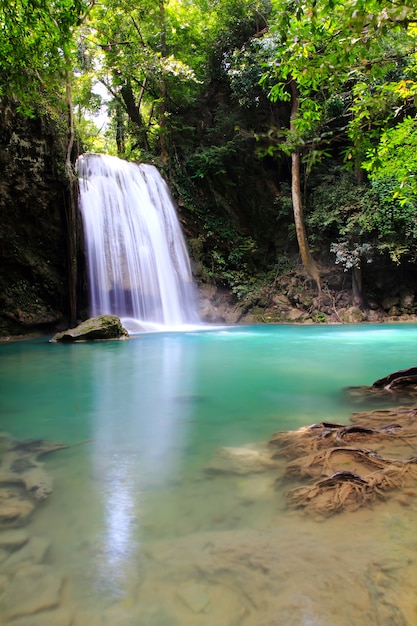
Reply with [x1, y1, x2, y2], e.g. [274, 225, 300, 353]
[206, 445, 281, 475]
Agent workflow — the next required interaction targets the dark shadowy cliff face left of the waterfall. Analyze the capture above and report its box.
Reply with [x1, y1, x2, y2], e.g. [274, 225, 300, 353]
[0, 103, 72, 336]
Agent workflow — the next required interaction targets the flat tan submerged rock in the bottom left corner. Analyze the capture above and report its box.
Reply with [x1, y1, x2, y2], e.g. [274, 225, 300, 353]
[2, 565, 63, 619]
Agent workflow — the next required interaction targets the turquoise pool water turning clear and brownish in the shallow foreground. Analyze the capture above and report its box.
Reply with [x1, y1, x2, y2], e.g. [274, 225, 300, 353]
[0, 325, 417, 626]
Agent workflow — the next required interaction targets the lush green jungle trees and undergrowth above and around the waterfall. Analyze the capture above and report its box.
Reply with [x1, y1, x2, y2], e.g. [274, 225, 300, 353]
[0, 0, 417, 299]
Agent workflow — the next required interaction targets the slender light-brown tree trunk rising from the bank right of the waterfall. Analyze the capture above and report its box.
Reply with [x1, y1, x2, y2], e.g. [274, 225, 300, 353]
[290, 80, 321, 291]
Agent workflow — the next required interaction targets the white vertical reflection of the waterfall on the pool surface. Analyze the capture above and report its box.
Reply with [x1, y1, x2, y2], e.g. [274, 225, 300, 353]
[91, 336, 195, 594]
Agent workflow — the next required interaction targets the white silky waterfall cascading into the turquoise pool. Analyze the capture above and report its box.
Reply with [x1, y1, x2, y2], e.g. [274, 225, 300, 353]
[77, 154, 199, 332]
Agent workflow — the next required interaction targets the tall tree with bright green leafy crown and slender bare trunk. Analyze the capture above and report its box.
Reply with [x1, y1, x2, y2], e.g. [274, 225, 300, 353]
[262, 0, 415, 288]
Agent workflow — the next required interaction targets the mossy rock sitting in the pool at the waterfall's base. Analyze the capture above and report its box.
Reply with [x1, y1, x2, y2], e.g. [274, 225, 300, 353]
[52, 315, 129, 342]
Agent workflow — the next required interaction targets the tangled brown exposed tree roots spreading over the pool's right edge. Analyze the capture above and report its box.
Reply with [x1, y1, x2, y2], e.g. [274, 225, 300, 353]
[269, 400, 417, 517]
